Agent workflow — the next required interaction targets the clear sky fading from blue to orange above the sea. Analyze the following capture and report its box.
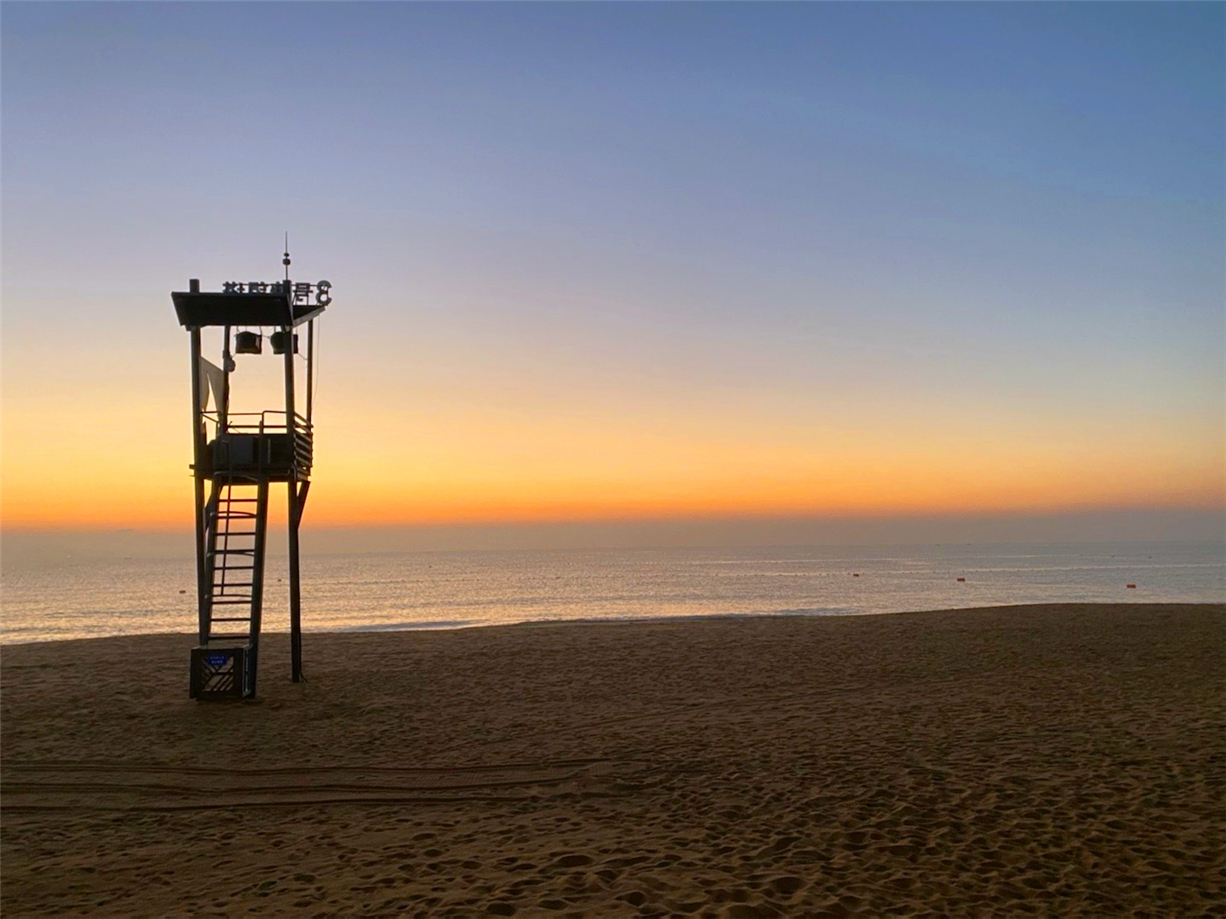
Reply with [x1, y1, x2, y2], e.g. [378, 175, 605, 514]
[0, 1, 1226, 542]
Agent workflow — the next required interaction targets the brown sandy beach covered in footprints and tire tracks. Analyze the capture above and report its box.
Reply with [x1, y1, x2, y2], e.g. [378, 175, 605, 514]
[0, 604, 1226, 917]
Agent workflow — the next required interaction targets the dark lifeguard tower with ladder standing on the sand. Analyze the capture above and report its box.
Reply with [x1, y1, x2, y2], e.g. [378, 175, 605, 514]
[170, 246, 332, 700]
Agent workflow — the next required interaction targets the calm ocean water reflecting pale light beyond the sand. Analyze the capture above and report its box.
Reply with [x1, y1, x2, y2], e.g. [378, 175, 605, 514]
[0, 543, 1226, 642]
